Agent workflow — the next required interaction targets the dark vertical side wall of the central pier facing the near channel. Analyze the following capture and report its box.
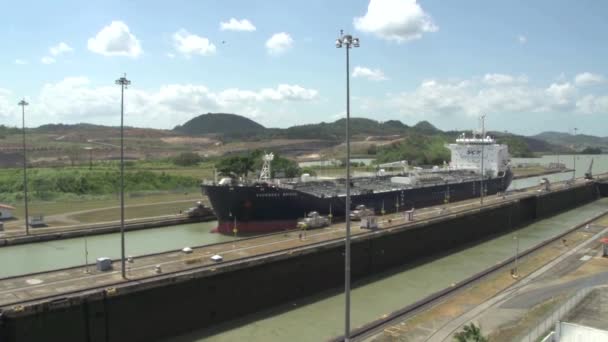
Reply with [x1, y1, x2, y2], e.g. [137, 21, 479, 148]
[0, 184, 598, 342]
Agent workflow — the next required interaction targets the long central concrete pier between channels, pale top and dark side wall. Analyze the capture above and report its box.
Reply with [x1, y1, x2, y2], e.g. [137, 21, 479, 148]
[0, 180, 600, 341]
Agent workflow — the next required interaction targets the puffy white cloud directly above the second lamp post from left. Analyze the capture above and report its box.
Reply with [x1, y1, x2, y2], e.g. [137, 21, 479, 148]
[87, 21, 143, 58]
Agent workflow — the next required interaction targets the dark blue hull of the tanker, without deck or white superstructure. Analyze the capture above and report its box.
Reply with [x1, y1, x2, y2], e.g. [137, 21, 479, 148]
[203, 171, 512, 234]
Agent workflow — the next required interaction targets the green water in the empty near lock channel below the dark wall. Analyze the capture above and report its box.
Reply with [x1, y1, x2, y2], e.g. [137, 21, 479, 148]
[170, 198, 608, 342]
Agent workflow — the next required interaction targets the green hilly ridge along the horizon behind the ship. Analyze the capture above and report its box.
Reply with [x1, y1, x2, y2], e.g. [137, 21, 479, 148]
[0, 113, 584, 156]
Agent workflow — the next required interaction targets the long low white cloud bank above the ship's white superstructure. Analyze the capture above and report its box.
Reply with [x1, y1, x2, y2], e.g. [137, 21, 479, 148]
[387, 74, 608, 117]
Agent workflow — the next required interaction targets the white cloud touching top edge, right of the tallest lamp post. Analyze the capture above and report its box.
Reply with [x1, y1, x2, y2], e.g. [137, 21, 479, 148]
[353, 0, 439, 43]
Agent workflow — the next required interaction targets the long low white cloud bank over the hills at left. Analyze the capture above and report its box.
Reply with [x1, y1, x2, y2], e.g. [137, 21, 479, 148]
[0, 77, 318, 128]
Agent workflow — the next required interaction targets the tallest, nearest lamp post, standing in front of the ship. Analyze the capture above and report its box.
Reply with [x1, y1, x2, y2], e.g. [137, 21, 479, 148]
[336, 30, 359, 341]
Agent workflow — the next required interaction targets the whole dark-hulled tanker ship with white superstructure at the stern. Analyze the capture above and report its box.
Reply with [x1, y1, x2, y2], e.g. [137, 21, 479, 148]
[202, 134, 512, 234]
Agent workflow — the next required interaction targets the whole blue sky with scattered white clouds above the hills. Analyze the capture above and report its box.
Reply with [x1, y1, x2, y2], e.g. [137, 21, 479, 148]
[0, 0, 608, 135]
